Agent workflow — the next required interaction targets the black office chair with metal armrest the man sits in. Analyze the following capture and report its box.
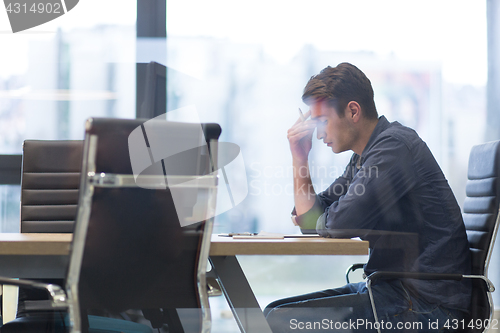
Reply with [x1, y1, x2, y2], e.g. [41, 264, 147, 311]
[347, 141, 500, 332]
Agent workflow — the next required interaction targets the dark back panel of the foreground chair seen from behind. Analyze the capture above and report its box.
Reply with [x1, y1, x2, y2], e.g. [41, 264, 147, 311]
[74, 119, 220, 311]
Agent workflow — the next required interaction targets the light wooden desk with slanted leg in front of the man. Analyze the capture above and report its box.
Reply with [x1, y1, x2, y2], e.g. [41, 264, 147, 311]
[0, 233, 368, 333]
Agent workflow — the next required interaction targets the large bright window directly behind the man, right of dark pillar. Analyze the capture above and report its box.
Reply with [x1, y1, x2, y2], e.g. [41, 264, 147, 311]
[166, 0, 487, 232]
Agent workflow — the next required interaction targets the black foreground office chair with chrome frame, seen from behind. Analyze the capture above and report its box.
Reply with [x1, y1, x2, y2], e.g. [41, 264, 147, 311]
[0, 119, 220, 332]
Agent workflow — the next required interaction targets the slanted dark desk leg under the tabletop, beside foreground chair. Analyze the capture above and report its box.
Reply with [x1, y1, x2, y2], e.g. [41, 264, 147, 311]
[210, 256, 272, 333]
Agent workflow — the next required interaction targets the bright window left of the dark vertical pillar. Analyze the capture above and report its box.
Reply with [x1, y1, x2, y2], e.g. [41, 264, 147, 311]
[0, 0, 137, 232]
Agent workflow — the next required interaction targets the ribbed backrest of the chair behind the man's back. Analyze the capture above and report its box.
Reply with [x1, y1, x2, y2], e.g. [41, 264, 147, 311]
[463, 141, 500, 328]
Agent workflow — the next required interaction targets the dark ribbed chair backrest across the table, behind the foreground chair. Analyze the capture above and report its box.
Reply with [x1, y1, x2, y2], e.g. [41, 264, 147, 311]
[21, 140, 83, 233]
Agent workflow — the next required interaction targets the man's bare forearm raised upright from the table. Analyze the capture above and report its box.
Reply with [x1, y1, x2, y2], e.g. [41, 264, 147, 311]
[293, 160, 316, 215]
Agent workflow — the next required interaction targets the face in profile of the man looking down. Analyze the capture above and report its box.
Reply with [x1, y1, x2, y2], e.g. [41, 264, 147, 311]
[310, 100, 357, 154]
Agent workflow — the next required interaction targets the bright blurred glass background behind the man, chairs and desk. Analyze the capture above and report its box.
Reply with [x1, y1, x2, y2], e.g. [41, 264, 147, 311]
[0, 0, 500, 332]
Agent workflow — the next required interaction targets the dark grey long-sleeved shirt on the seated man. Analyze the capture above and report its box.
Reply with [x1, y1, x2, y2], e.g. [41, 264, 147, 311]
[297, 116, 471, 310]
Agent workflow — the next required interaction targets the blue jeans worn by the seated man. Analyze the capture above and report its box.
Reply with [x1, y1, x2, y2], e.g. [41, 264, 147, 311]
[264, 281, 465, 333]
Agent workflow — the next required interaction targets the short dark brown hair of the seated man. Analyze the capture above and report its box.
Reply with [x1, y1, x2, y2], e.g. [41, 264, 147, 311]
[302, 62, 378, 119]
